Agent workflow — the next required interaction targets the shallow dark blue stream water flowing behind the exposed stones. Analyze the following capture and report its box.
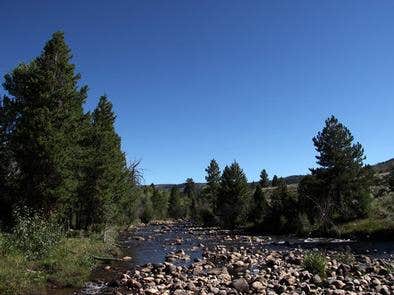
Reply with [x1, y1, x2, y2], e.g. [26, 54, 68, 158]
[47, 223, 394, 295]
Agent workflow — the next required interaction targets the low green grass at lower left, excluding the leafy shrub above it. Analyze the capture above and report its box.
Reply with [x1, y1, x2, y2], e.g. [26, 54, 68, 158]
[0, 234, 113, 295]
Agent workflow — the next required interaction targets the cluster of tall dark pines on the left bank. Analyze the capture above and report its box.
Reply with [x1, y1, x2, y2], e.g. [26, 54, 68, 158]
[0, 32, 142, 228]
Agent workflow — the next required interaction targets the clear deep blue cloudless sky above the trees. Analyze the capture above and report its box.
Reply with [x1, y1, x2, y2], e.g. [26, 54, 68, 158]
[0, 0, 394, 183]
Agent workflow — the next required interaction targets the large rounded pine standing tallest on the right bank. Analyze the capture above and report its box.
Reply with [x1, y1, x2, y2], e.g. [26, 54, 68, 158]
[307, 116, 373, 230]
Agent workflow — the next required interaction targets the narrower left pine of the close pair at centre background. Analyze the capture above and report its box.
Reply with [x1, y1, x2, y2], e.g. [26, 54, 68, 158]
[204, 159, 221, 210]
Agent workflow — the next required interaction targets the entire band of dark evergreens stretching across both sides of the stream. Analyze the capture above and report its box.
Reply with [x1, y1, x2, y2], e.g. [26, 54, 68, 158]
[0, 32, 394, 236]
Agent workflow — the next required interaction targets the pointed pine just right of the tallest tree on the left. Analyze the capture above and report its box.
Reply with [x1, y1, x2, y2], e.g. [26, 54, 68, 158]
[81, 96, 133, 226]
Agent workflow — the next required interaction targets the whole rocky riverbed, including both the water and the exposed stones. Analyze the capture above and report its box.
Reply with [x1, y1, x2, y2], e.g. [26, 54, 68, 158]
[77, 223, 394, 295]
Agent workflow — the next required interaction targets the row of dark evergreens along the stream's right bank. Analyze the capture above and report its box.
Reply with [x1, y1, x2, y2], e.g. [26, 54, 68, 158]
[160, 116, 378, 234]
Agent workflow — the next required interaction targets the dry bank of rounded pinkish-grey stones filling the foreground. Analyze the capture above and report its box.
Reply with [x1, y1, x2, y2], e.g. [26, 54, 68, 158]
[117, 246, 394, 294]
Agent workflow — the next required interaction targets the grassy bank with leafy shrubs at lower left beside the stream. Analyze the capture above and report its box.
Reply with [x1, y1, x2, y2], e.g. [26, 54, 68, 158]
[0, 215, 116, 294]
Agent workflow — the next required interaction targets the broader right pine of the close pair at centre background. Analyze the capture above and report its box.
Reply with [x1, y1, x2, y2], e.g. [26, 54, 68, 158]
[217, 162, 249, 228]
